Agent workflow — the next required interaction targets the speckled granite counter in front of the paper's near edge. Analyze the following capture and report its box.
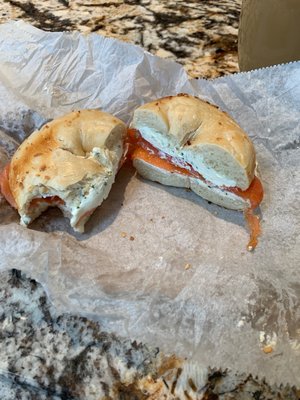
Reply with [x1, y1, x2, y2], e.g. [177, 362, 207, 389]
[0, 270, 300, 400]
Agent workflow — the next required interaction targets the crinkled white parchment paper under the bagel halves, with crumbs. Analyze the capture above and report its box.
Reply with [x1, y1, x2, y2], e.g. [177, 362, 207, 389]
[0, 22, 300, 385]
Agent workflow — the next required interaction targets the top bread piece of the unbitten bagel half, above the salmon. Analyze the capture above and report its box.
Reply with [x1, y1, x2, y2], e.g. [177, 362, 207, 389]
[131, 94, 256, 190]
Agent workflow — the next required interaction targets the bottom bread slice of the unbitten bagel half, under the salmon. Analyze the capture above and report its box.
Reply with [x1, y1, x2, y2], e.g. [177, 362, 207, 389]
[133, 158, 250, 211]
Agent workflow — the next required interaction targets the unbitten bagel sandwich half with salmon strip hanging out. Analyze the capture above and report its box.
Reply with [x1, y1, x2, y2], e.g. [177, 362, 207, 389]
[129, 94, 263, 250]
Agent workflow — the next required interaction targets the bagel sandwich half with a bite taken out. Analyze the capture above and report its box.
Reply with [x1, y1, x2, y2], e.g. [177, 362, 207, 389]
[0, 110, 126, 232]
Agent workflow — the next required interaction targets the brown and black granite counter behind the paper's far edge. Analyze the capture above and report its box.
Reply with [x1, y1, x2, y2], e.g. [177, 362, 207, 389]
[0, 0, 241, 78]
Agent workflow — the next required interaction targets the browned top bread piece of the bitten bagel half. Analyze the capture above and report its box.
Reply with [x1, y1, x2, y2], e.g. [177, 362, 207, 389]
[9, 110, 126, 209]
